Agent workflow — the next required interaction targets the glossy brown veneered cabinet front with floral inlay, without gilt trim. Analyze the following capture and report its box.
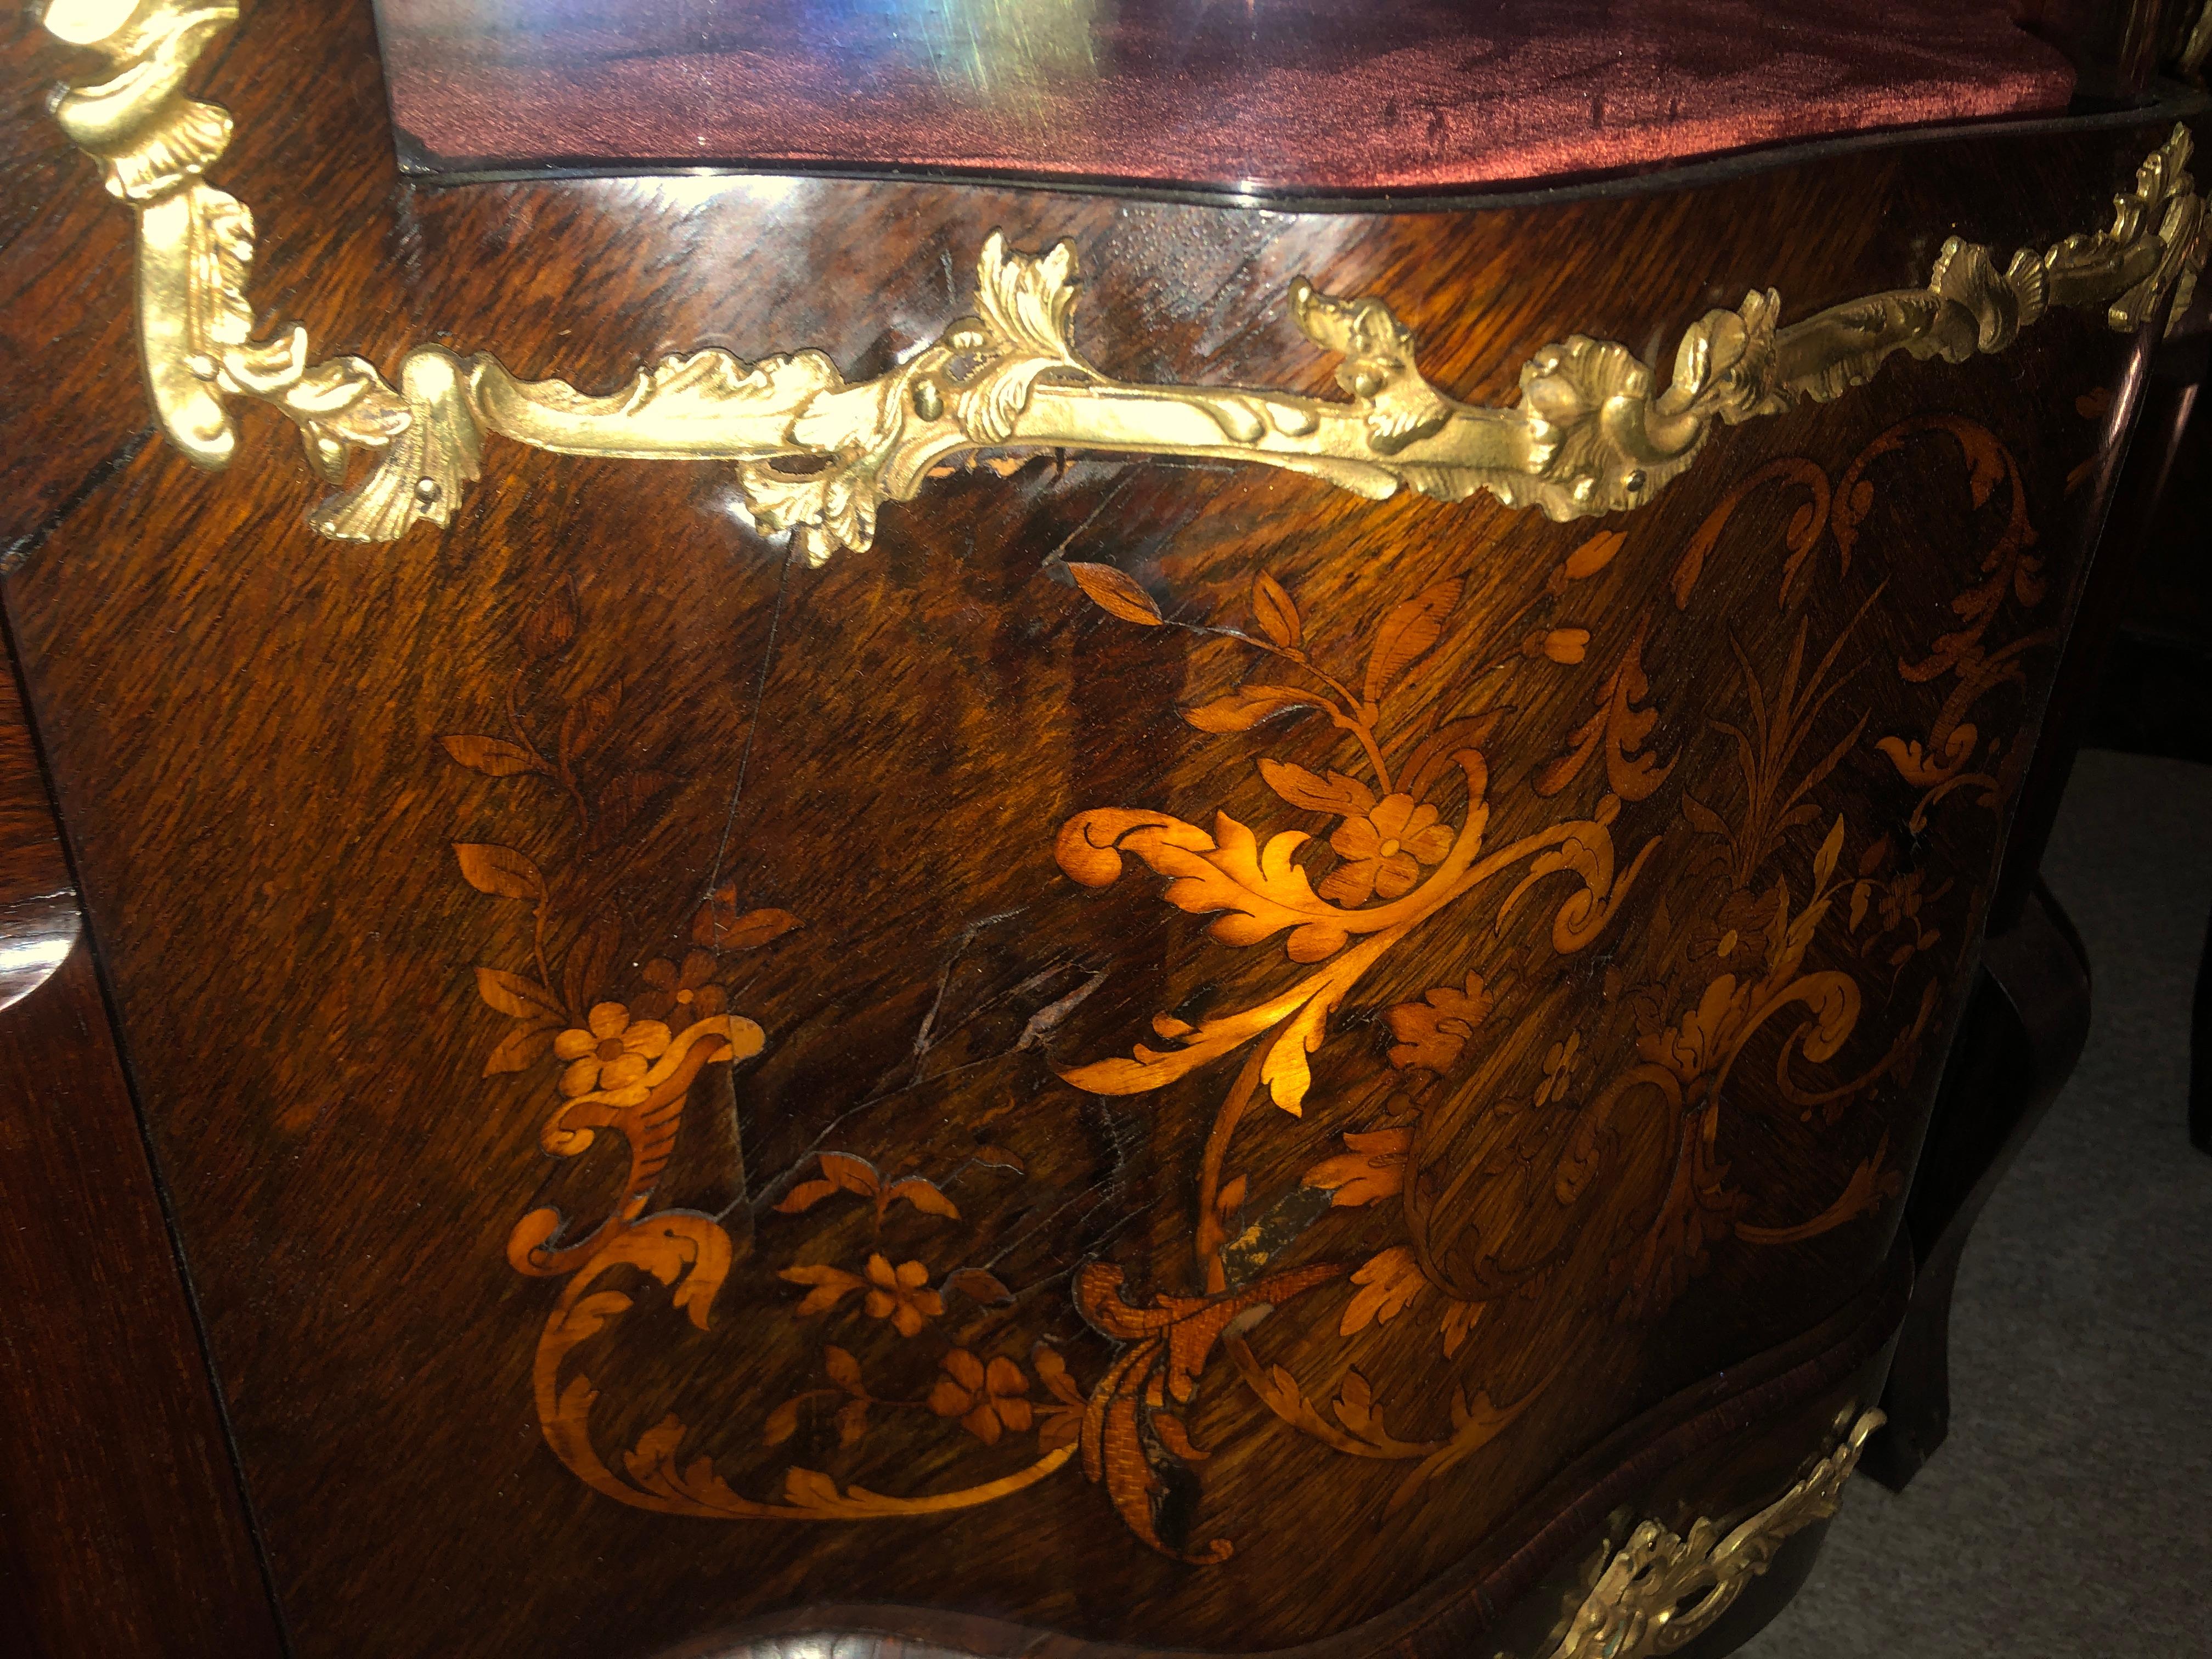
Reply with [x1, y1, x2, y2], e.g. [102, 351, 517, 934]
[0, 2, 2163, 1659]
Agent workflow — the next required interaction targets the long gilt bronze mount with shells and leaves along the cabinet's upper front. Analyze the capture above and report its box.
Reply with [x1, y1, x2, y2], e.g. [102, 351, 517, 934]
[44, 0, 2203, 564]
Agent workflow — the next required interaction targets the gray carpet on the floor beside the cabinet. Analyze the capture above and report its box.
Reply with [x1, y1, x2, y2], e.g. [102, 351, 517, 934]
[1743, 750, 2212, 1659]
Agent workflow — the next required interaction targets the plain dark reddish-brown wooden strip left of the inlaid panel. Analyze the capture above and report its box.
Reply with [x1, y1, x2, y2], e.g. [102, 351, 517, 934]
[0, 619, 283, 1659]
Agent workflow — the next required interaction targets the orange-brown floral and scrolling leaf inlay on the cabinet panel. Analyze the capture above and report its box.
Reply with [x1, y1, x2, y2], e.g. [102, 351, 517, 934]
[411, 387, 2053, 1571]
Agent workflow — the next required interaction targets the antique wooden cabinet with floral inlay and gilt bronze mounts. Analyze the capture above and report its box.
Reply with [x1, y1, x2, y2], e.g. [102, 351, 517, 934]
[0, 0, 2201, 1659]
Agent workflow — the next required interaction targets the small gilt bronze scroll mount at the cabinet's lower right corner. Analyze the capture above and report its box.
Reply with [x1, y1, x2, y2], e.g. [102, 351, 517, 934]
[1498, 1411, 1884, 1659]
